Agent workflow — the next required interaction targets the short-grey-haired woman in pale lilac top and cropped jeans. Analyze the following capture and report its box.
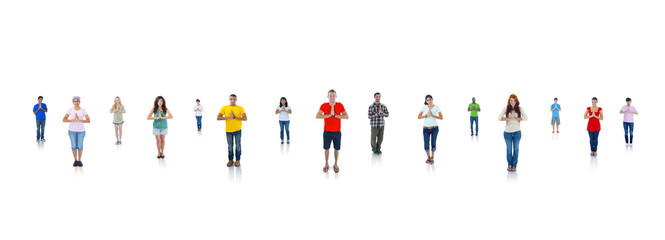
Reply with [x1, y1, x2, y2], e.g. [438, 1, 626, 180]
[62, 96, 90, 167]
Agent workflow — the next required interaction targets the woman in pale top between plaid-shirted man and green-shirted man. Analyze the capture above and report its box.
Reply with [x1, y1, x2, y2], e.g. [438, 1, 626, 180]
[418, 94, 443, 165]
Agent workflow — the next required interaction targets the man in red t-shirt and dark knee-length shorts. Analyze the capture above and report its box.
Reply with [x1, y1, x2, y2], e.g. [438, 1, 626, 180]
[316, 89, 349, 173]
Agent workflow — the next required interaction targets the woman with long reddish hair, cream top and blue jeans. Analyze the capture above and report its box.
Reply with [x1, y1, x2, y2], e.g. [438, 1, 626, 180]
[499, 94, 527, 172]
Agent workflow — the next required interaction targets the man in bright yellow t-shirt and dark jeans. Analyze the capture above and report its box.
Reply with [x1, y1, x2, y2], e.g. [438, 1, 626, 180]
[217, 94, 247, 167]
